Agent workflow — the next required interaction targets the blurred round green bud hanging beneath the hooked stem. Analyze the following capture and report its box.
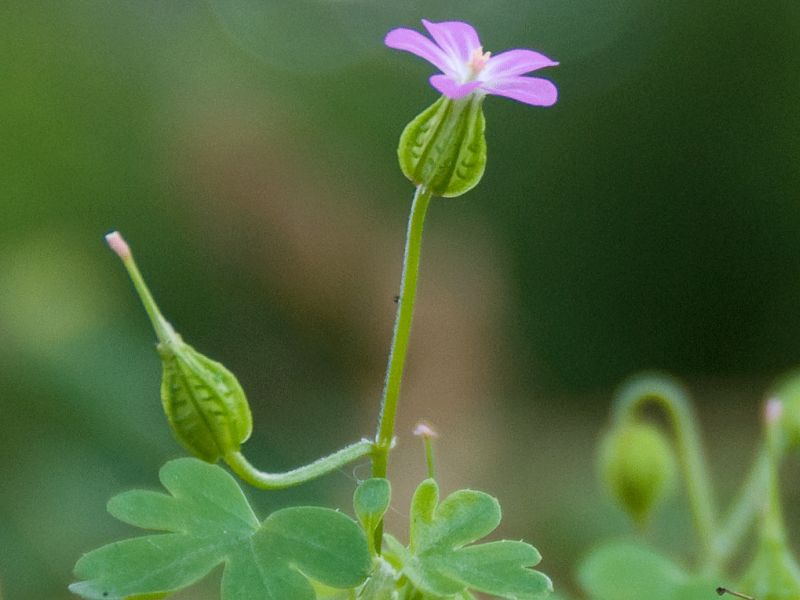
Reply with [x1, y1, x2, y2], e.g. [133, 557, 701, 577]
[600, 422, 676, 525]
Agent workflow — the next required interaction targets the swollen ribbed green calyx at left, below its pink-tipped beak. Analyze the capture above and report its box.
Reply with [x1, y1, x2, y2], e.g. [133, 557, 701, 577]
[158, 335, 253, 462]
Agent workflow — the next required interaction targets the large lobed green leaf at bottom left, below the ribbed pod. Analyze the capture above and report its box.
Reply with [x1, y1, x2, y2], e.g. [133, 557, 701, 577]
[70, 458, 370, 600]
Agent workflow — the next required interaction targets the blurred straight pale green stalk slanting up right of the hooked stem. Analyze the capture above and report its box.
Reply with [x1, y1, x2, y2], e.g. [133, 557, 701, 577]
[716, 446, 771, 567]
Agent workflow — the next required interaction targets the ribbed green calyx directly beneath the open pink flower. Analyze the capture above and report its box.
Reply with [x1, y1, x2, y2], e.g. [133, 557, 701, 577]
[397, 94, 486, 198]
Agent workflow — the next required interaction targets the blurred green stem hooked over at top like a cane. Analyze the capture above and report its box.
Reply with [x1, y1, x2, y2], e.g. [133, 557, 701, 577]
[614, 375, 719, 569]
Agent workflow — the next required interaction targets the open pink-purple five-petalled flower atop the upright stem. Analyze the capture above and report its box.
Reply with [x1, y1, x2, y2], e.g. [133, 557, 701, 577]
[384, 19, 558, 106]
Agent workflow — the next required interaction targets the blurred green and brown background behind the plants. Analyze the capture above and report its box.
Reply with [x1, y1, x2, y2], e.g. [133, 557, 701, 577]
[0, 0, 800, 600]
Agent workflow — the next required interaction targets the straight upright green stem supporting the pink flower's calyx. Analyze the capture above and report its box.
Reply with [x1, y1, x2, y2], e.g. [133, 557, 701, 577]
[372, 186, 431, 477]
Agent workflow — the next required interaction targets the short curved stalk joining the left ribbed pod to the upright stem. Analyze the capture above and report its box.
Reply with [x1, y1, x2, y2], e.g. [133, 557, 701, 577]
[225, 440, 374, 490]
